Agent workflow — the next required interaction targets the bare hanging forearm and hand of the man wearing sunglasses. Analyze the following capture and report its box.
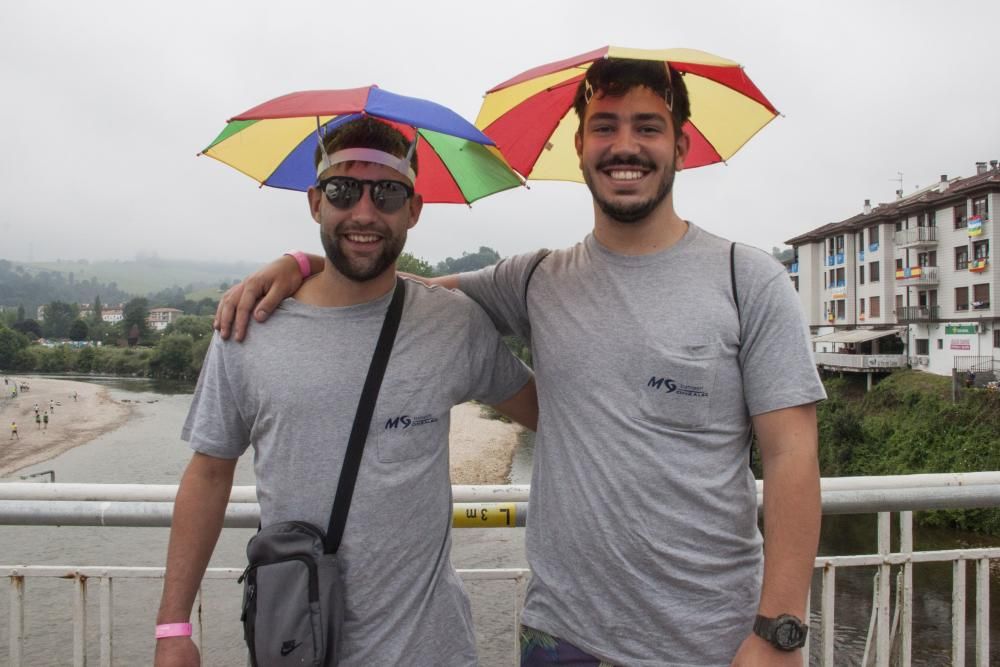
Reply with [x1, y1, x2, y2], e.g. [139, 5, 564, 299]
[155, 452, 237, 667]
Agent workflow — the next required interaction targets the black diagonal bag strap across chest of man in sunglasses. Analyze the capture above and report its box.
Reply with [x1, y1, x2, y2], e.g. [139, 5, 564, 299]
[325, 276, 406, 554]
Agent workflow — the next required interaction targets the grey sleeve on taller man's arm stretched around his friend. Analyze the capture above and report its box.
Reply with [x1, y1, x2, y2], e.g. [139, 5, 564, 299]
[458, 250, 548, 341]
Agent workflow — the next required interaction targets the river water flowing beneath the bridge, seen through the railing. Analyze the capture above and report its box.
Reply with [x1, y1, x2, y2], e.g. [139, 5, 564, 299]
[0, 379, 1000, 667]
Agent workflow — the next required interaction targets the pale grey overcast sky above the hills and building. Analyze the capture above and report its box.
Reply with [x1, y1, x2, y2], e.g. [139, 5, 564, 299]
[0, 0, 1000, 262]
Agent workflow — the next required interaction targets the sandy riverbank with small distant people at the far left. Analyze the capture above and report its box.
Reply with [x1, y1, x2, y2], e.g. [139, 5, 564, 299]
[0, 376, 131, 477]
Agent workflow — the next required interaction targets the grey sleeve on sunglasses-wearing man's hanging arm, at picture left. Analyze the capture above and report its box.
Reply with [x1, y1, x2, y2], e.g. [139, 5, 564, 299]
[181, 333, 251, 459]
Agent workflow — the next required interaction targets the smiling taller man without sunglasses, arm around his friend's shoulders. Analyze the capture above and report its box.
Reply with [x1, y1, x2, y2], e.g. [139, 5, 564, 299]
[223, 59, 825, 666]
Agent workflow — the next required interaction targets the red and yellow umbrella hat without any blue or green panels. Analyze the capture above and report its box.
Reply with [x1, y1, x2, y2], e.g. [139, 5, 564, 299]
[476, 46, 778, 183]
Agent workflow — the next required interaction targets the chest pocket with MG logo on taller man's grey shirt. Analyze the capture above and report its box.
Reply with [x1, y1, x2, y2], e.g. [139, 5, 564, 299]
[632, 343, 720, 431]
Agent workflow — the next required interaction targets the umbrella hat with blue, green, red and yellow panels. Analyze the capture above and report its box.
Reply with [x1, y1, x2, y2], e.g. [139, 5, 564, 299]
[201, 86, 523, 204]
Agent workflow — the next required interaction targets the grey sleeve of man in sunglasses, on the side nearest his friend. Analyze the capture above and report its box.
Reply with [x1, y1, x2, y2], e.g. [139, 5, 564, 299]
[464, 304, 531, 405]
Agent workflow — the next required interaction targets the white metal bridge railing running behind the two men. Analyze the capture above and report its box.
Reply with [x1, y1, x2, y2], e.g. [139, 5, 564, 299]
[0, 472, 1000, 667]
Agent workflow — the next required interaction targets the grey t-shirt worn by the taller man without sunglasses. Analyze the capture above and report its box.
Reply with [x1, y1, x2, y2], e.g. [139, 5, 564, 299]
[460, 225, 825, 667]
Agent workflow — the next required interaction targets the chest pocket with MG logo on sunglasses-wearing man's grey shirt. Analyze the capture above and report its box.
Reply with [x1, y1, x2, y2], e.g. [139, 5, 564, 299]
[372, 373, 449, 463]
